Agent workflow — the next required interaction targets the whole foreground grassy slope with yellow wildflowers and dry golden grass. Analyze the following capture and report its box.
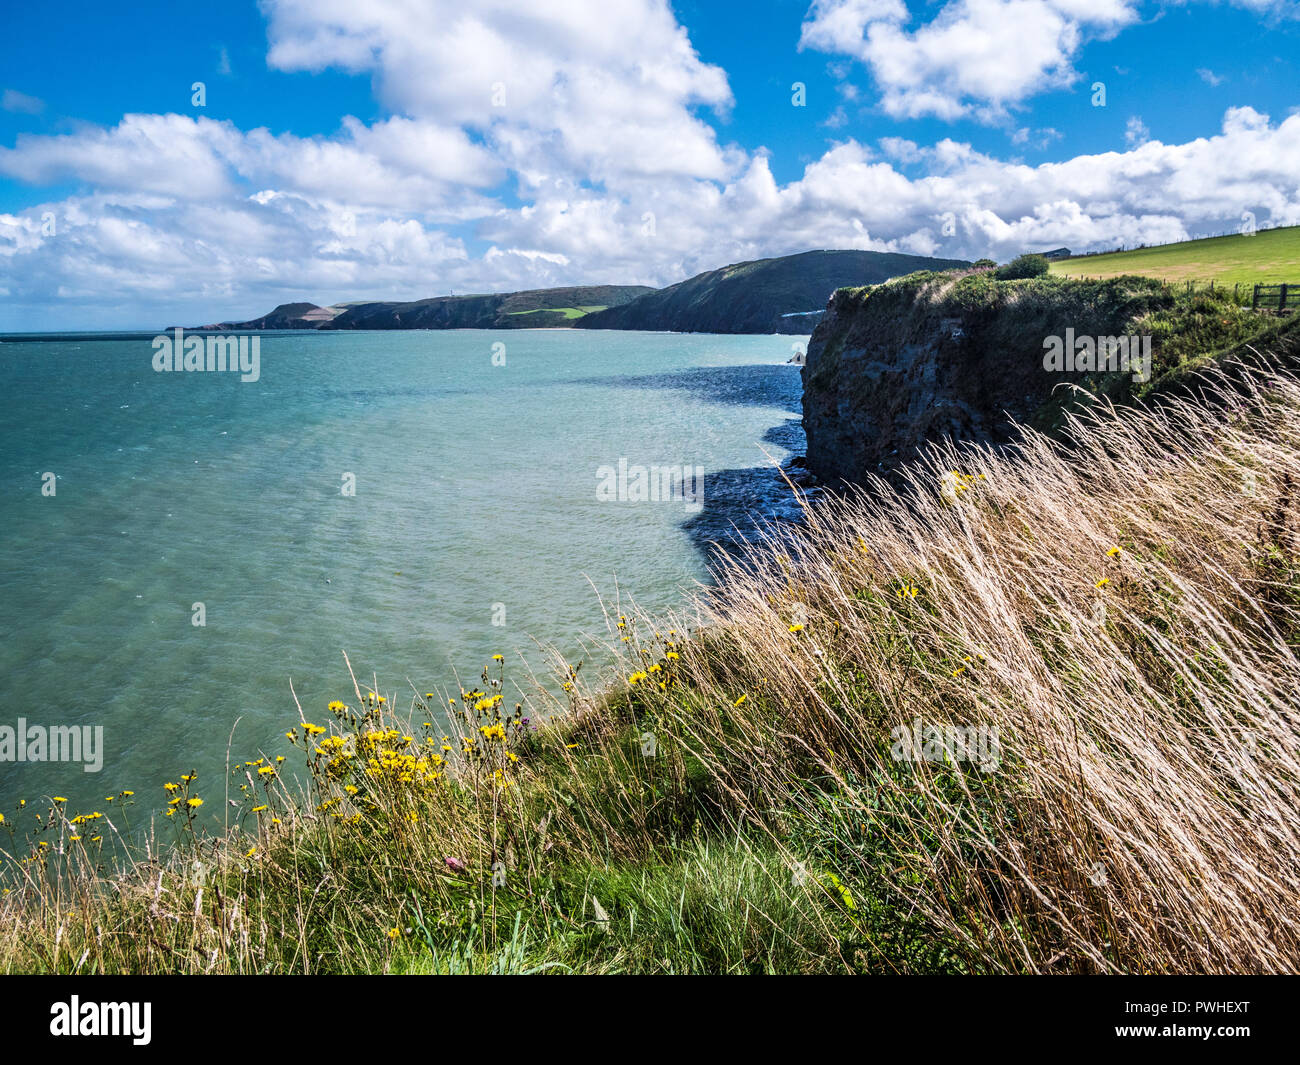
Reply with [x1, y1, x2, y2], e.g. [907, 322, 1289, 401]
[0, 343, 1300, 973]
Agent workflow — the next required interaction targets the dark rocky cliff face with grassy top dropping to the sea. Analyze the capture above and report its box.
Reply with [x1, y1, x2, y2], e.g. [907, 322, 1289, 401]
[802, 272, 1247, 482]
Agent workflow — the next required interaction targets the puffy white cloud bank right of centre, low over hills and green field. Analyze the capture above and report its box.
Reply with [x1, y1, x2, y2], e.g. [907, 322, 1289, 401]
[473, 108, 1300, 283]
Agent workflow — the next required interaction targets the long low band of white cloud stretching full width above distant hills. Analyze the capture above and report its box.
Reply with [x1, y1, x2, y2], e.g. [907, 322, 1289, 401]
[10, 108, 1300, 325]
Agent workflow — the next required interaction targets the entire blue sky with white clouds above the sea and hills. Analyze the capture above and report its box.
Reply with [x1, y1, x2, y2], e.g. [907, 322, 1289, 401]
[0, 0, 1300, 332]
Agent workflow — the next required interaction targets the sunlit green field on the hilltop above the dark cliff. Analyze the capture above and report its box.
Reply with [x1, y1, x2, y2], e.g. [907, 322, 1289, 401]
[1052, 226, 1300, 285]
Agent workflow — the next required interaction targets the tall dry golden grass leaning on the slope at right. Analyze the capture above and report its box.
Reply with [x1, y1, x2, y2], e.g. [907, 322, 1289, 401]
[644, 361, 1300, 971]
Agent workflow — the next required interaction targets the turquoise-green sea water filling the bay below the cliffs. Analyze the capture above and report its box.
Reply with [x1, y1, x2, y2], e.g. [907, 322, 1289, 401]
[0, 330, 802, 827]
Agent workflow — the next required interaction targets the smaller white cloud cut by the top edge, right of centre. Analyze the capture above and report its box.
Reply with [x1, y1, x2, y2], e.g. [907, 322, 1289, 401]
[800, 0, 1138, 121]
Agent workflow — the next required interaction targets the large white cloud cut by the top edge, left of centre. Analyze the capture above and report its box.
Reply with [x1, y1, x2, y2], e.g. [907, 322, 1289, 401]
[268, 0, 736, 181]
